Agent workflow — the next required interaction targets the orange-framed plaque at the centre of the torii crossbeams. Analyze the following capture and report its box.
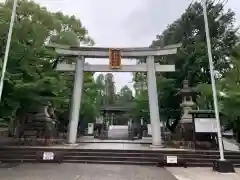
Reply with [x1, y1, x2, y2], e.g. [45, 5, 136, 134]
[109, 49, 122, 69]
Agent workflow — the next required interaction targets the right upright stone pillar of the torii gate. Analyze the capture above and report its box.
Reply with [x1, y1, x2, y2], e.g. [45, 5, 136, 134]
[146, 56, 162, 146]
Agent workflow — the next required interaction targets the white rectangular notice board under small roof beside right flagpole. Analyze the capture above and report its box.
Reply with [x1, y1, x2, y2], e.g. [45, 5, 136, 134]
[194, 118, 217, 133]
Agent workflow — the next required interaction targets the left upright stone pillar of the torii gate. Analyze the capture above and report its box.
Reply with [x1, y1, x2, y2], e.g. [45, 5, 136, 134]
[68, 57, 84, 144]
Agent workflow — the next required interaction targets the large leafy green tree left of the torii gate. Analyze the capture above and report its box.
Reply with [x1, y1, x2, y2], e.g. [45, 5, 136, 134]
[0, 0, 94, 132]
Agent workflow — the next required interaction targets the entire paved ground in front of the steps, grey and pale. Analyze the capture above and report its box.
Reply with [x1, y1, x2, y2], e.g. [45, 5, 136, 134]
[0, 163, 240, 180]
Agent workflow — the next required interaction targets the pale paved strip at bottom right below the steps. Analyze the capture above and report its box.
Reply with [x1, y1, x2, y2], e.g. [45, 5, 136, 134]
[167, 167, 240, 180]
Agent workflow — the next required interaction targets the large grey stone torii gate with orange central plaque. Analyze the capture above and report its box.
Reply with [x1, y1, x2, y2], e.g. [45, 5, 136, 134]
[50, 44, 181, 146]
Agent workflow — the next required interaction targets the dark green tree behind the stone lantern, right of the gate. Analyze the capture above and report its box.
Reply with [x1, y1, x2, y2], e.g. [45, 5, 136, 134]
[135, 0, 238, 119]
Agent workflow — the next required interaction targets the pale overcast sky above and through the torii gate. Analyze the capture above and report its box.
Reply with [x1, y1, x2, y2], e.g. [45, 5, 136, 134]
[0, 0, 240, 91]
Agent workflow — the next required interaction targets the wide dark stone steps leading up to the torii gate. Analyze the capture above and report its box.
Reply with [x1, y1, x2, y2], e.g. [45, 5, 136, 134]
[0, 147, 240, 167]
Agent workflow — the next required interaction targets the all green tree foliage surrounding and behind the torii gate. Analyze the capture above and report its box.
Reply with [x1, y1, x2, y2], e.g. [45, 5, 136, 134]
[0, 0, 240, 139]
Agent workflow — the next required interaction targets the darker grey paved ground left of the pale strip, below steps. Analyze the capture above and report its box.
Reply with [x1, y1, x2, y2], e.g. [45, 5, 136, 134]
[0, 164, 177, 180]
